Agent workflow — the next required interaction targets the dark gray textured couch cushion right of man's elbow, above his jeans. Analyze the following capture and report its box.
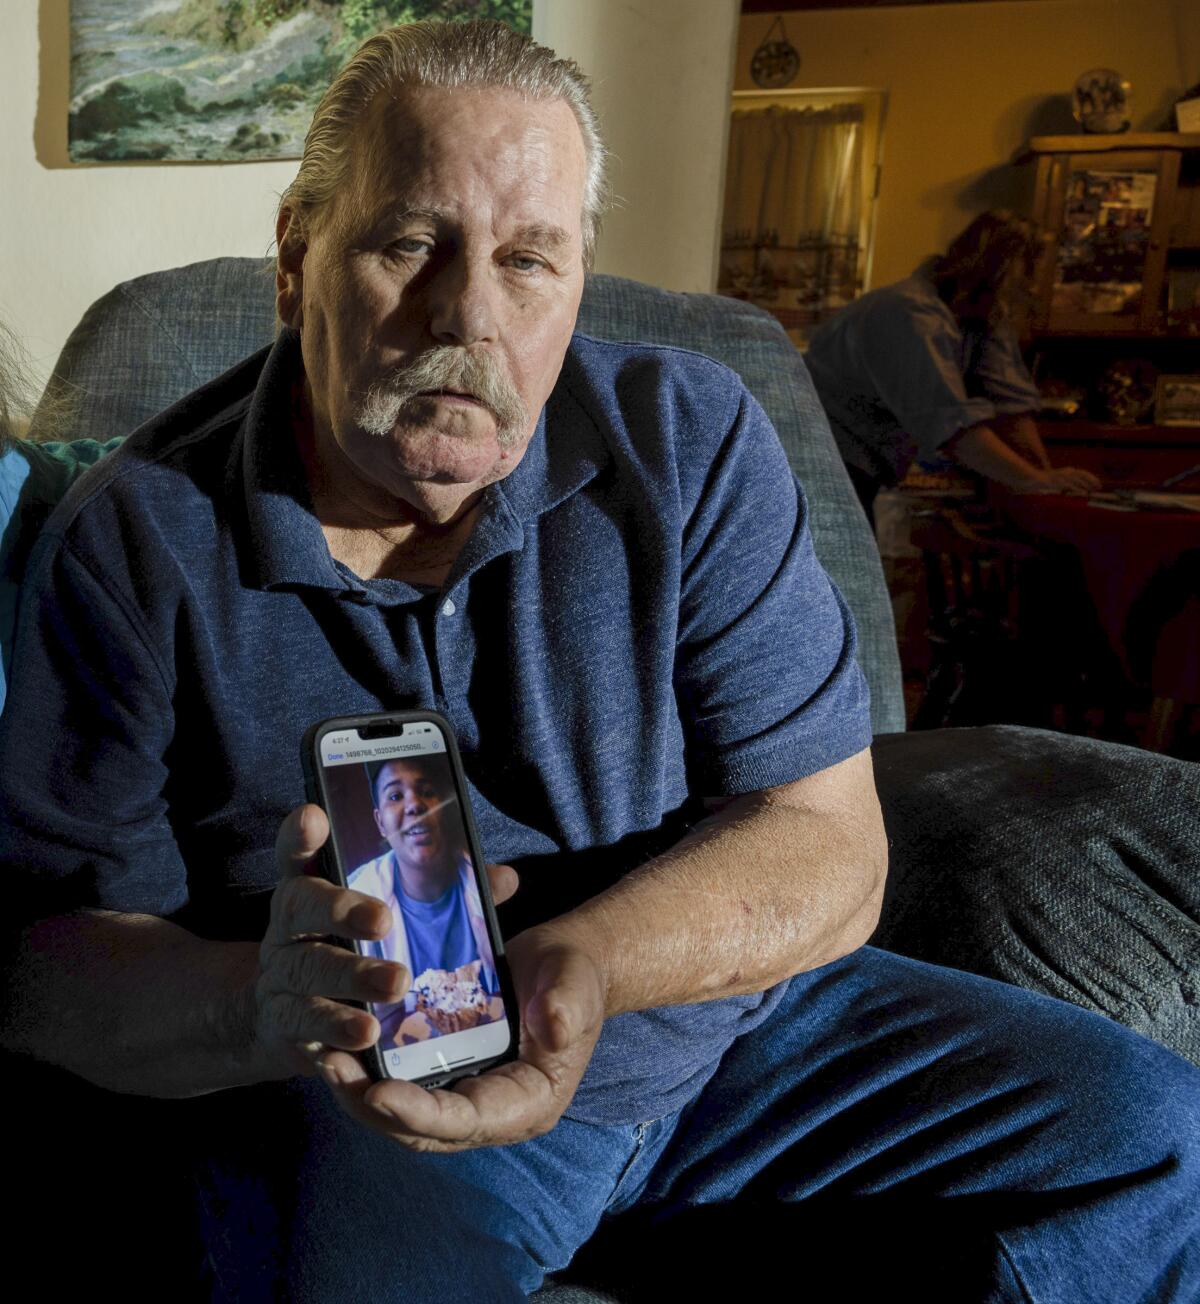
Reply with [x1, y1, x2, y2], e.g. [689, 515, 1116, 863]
[871, 725, 1200, 1064]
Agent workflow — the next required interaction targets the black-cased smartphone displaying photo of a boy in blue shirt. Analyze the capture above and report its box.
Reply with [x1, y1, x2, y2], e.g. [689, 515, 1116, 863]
[301, 711, 518, 1088]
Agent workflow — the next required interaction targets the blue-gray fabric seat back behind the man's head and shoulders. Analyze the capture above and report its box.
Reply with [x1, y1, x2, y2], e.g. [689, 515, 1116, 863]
[33, 258, 904, 733]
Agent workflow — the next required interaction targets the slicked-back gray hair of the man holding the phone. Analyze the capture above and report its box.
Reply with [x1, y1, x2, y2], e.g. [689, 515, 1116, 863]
[279, 18, 608, 269]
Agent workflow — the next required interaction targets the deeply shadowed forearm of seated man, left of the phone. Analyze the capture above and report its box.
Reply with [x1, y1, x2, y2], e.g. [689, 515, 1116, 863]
[3, 910, 274, 1097]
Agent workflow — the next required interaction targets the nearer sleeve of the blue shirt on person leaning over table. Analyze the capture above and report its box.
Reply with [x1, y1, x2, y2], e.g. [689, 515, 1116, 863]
[861, 296, 997, 462]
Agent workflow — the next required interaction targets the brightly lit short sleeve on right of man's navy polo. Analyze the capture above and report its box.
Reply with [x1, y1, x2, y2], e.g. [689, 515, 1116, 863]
[674, 391, 871, 797]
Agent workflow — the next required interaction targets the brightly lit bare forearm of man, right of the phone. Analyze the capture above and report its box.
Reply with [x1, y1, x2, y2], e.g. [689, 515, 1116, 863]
[545, 752, 887, 1016]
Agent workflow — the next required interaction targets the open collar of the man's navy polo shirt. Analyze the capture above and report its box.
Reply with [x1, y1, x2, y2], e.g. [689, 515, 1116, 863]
[237, 329, 609, 595]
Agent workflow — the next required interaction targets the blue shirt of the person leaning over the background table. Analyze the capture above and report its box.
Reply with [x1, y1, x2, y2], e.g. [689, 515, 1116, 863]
[805, 264, 1041, 485]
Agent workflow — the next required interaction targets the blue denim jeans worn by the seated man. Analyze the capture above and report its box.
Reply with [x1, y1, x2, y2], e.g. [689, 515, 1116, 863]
[201, 947, 1200, 1304]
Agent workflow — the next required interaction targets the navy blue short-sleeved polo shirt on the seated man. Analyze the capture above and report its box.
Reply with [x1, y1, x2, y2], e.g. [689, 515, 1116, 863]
[0, 323, 870, 1123]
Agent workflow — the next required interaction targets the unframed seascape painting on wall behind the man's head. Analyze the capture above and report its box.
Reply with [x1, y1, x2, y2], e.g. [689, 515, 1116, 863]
[68, 0, 532, 163]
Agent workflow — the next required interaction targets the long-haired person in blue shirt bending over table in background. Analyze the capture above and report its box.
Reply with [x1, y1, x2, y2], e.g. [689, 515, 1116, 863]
[805, 211, 1100, 518]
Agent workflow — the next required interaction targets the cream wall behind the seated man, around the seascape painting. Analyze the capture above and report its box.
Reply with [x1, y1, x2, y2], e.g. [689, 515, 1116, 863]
[0, 0, 738, 401]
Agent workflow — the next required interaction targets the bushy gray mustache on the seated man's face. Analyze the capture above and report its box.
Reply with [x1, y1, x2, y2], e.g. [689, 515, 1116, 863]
[357, 344, 528, 445]
